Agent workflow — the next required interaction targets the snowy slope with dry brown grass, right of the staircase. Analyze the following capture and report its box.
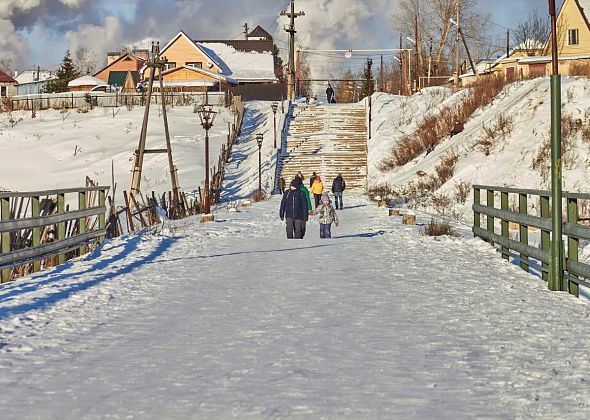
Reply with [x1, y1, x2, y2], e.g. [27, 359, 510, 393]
[369, 78, 590, 218]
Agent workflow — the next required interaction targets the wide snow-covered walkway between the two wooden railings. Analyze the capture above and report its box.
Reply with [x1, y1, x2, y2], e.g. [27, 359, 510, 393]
[0, 198, 590, 419]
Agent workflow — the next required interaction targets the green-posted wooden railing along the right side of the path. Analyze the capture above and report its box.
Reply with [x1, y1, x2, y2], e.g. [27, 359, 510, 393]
[472, 185, 590, 296]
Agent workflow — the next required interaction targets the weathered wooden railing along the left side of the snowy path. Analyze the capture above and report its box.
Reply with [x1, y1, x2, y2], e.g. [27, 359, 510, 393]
[0, 186, 109, 283]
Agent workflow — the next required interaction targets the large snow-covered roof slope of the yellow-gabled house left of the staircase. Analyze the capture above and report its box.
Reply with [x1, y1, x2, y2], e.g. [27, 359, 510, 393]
[199, 43, 277, 82]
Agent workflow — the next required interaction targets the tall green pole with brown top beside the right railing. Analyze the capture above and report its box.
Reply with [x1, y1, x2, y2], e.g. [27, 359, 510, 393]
[549, 0, 568, 291]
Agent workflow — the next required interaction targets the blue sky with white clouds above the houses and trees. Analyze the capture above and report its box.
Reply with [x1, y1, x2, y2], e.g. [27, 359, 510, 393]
[6, 0, 563, 66]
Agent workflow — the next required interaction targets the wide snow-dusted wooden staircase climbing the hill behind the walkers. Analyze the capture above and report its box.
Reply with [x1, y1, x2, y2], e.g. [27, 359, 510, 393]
[279, 101, 367, 192]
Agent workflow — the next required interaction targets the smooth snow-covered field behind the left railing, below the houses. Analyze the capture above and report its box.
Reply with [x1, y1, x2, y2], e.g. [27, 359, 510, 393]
[0, 104, 272, 203]
